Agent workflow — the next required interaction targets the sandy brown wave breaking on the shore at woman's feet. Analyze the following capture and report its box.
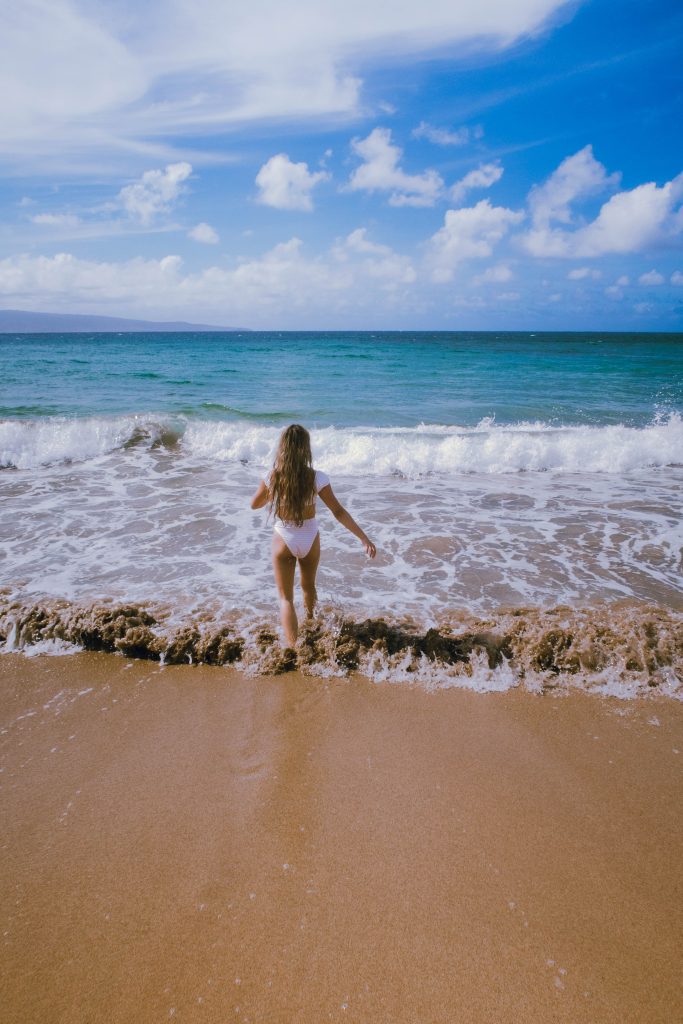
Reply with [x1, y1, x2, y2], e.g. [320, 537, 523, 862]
[0, 599, 683, 699]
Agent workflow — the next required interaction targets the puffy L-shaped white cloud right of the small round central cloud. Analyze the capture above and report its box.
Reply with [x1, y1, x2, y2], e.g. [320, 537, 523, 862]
[346, 128, 443, 206]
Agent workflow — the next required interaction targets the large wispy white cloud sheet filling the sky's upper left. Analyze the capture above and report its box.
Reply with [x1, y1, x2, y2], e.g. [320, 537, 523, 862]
[0, 0, 565, 170]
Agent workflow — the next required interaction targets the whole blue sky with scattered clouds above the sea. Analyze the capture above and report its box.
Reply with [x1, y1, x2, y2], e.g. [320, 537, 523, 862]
[0, 0, 683, 331]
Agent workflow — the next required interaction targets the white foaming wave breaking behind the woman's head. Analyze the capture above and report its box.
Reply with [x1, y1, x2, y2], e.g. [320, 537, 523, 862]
[0, 413, 683, 477]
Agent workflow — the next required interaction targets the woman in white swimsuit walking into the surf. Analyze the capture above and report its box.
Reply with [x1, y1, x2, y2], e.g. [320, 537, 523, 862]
[251, 423, 377, 647]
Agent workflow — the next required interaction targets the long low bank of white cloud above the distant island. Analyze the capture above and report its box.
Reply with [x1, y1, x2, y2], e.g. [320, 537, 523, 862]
[0, 228, 416, 325]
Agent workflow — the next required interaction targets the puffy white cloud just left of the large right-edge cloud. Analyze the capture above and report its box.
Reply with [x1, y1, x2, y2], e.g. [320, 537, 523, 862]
[429, 199, 524, 282]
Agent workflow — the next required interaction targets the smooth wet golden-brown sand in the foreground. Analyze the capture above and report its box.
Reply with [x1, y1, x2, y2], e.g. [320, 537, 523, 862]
[0, 653, 683, 1024]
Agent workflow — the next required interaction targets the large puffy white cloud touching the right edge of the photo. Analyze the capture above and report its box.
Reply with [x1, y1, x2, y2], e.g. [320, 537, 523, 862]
[520, 146, 683, 258]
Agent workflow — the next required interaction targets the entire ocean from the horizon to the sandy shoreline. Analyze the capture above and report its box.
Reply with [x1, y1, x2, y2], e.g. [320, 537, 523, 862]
[0, 332, 683, 696]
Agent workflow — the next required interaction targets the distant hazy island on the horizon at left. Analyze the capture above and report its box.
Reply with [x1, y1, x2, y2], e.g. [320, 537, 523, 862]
[0, 309, 248, 334]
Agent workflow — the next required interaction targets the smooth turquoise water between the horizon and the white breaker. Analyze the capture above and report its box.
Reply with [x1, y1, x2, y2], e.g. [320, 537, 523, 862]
[0, 333, 683, 427]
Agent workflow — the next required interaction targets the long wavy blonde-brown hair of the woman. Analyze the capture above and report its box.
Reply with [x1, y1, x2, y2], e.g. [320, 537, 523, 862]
[268, 423, 315, 526]
